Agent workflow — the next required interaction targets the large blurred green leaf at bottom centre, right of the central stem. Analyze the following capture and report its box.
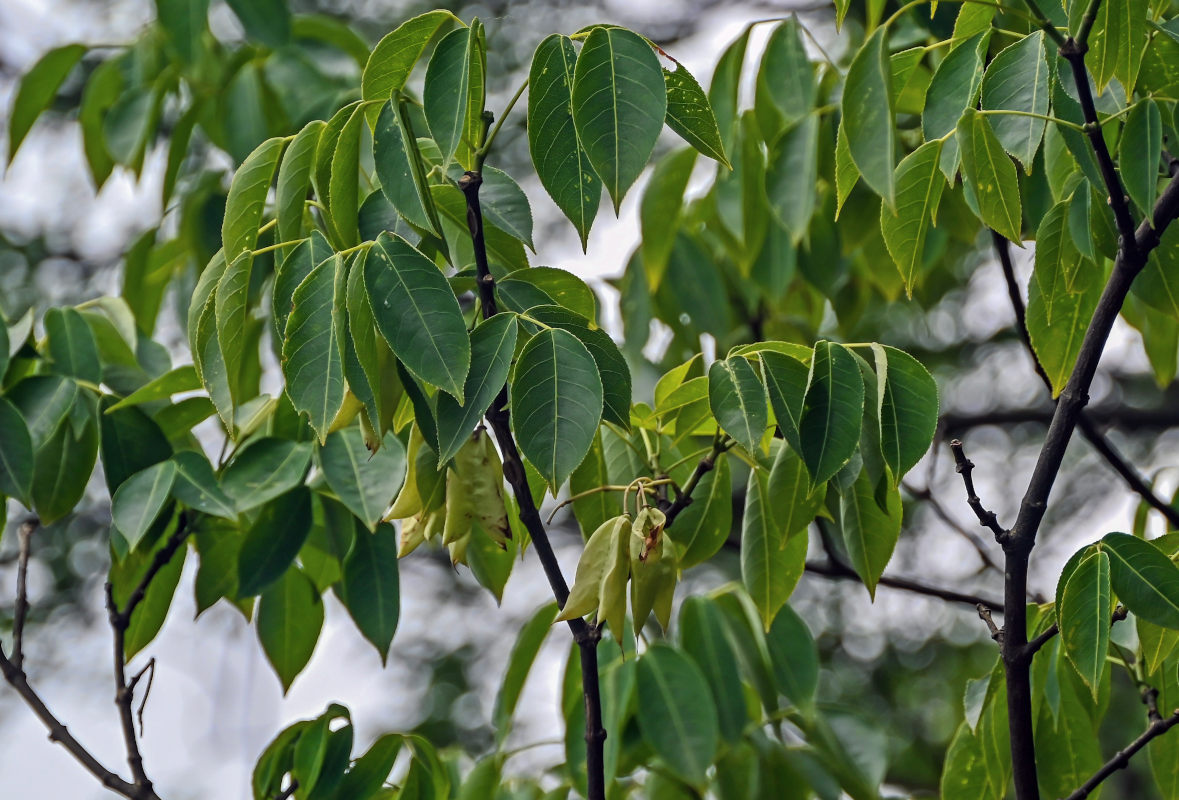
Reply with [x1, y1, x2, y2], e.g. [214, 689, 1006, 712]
[637, 643, 719, 788]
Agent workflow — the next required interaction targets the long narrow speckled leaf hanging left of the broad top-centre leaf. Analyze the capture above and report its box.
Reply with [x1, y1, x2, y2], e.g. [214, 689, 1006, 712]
[528, 33, 601, 250]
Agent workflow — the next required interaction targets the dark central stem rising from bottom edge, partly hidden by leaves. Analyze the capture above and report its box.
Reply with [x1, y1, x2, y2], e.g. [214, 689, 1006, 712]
[459, 172, 603, 800]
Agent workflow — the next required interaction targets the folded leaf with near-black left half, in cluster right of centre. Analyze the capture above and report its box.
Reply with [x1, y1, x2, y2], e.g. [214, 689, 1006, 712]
[798, 341, 864, 485]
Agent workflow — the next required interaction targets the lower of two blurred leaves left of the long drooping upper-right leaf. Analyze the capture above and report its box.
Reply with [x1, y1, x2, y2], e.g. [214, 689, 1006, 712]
[765, 114, 819, 245]
